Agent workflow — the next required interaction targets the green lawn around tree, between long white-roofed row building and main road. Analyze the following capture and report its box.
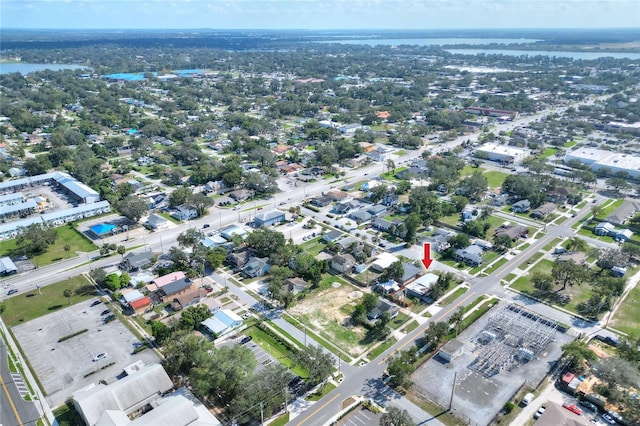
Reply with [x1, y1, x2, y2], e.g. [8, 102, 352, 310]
[0, 225, 97, 267]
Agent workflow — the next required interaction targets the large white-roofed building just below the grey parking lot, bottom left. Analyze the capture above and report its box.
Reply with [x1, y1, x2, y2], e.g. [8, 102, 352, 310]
[72, 364, 173, 426]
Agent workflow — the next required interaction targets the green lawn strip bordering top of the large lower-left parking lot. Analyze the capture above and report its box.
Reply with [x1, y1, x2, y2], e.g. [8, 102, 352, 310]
[2, 275, 96, 327]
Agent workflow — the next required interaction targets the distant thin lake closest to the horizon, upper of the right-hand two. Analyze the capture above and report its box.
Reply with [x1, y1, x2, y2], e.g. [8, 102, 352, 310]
[319, 38, 539, 46]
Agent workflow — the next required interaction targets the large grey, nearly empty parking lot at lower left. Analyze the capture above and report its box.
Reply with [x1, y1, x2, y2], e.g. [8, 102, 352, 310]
[12, 298, 159, 407]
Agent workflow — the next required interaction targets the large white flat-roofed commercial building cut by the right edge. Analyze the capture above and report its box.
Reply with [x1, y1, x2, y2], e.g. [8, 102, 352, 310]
[564, 148, 640, 179]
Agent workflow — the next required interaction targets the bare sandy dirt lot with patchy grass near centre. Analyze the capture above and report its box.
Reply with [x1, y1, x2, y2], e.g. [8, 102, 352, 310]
[289, 285, 366, 356]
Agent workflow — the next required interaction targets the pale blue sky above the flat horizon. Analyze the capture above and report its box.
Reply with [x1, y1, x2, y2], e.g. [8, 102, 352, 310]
[0, 0, 640, 29]
